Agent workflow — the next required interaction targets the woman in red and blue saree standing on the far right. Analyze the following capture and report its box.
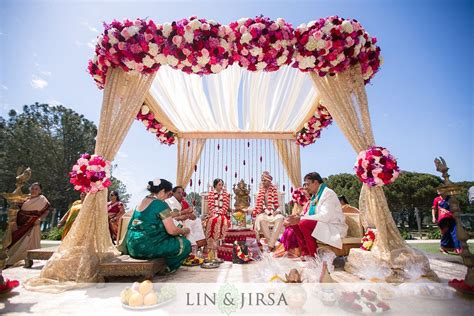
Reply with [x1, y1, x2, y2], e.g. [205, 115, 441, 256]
[432, 191, 462, 254]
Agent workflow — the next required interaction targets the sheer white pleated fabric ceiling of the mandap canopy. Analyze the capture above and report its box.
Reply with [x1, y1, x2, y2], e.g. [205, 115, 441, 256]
[150, 65, 318, 132]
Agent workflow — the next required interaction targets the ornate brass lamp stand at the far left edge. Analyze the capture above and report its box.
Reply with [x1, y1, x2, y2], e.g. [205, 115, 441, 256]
[0, 168, 31, 287]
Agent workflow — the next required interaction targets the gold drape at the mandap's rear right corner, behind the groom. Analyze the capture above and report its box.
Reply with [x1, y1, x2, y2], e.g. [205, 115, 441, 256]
[273, 139, 301, 188]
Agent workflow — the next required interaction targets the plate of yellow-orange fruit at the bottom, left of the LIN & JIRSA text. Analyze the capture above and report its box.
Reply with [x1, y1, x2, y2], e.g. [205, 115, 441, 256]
[120, 280, 176, 310]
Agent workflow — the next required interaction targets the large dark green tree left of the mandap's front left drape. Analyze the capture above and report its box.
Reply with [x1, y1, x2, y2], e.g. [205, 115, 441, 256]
[0, 103, 131, 225]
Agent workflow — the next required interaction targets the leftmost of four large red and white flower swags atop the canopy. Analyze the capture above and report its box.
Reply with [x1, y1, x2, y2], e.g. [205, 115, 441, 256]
[88, 19, 166, 88]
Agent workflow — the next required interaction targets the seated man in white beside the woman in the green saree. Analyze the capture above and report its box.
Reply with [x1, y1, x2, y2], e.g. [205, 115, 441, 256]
[166, 186, 206, 252]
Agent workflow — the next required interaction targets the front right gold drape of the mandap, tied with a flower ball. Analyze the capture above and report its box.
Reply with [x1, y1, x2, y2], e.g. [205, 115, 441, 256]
[311, 65, 429, 273]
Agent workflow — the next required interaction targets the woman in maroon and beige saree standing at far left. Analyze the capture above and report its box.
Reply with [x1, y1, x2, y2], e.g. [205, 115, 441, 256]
[7, 182, 50, 265]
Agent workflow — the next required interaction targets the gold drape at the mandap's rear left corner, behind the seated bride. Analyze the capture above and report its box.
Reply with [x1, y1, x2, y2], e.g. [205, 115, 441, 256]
[176, 138, 206, 187]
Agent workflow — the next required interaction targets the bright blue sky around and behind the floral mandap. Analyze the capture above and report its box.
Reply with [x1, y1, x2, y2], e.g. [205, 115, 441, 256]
[0, 0, 474, 203]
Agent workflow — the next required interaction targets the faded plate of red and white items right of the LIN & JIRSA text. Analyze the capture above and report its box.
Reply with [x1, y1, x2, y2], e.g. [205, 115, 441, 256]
[339, 289, 390, 314]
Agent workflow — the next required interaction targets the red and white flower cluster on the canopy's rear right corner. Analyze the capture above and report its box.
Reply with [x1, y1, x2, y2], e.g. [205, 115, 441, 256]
[296, 103, 332, 147]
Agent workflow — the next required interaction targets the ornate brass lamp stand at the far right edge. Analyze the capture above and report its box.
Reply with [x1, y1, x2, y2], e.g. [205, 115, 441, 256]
[434, 157, 474, 295]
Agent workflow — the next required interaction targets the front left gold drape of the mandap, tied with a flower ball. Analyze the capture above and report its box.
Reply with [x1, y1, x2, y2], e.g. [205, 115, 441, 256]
[25, 68, 154, 292]
